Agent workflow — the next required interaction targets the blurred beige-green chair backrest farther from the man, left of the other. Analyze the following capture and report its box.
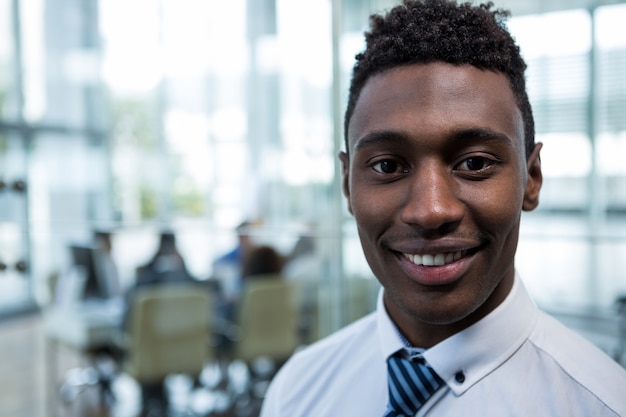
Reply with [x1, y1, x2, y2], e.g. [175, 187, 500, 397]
[125, 283, 211, 383]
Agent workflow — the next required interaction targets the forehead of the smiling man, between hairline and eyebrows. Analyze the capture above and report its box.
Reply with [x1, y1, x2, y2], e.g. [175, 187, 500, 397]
[348, 63, 524, 150]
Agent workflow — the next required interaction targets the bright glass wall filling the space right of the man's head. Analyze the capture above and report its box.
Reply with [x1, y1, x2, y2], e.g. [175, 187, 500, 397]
[510, 6, 626, 315]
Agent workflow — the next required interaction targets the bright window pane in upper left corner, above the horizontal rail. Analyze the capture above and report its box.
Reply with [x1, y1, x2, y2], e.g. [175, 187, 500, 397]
[18, 0, 103, 127]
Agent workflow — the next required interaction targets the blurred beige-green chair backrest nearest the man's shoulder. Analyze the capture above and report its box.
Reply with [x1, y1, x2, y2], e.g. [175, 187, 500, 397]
[235, 278, 299, 362]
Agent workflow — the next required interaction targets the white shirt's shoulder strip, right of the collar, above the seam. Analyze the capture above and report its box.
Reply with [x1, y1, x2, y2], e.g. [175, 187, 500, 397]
[530, 313, 626, 414]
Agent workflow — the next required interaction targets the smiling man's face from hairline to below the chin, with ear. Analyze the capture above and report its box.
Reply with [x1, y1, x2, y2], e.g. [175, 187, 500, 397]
[341, 63, 541, 339]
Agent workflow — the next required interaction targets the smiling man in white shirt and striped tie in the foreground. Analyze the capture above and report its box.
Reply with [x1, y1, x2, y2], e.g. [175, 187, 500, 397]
[262, 0, 626, 417]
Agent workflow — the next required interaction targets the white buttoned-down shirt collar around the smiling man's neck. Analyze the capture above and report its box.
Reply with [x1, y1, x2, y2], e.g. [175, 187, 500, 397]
[376, 272, 538, 395]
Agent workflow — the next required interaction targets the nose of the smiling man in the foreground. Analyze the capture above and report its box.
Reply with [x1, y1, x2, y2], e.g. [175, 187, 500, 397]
[401, 163, 464, 233]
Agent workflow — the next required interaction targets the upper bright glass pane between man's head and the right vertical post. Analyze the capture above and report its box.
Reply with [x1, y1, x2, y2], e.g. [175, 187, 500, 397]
[509, 10, 593, 211]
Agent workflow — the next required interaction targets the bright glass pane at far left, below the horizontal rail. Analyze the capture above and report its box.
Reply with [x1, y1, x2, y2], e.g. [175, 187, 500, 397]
[29, 133, 114, 302]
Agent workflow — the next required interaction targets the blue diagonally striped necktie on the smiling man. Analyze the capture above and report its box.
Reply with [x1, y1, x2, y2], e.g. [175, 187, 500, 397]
[384, 351, 445, 417]
